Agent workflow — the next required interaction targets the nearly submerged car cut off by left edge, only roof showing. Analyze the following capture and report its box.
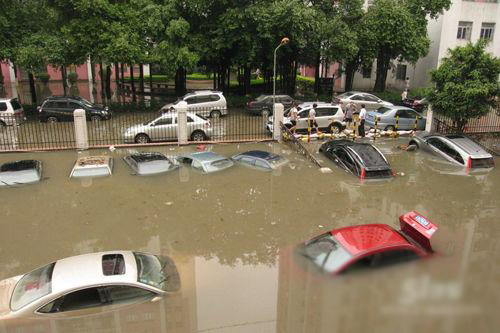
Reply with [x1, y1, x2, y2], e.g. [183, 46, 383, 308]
[0, 160, 42, 186]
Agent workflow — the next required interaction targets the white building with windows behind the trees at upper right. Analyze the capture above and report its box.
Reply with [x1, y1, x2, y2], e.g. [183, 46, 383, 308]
[353, 0, 500, 90]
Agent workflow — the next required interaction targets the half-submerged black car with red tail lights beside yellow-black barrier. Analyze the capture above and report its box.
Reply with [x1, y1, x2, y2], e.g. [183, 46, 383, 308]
[319, 140, 393, 179]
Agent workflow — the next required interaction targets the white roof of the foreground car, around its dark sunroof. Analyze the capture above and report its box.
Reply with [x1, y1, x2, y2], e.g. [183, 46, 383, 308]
[52, 251, 138, 293]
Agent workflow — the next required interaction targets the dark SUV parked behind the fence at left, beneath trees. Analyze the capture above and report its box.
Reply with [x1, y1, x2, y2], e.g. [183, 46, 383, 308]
[38, 96, 111, 123]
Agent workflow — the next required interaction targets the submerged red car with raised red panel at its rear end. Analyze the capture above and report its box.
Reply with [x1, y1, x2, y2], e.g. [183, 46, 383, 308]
[298, 212, 438, 274]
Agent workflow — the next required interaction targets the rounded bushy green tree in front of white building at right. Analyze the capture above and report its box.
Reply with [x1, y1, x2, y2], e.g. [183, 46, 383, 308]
[428, 40, 500, 132]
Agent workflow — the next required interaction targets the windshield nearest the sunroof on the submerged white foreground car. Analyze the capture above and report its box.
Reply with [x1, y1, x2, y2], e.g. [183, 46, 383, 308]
[134, 253, 180, 291]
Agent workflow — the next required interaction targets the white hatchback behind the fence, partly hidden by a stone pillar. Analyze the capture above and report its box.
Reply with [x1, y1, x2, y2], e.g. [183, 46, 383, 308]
[123, 112, 212, 143]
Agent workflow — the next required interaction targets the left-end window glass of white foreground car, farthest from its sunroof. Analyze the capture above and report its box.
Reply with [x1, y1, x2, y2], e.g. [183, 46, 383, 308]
[10, 263, 55, 311]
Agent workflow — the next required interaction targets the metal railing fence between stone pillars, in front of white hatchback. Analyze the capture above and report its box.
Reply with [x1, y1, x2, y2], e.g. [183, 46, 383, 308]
[0, 109, 272, 151]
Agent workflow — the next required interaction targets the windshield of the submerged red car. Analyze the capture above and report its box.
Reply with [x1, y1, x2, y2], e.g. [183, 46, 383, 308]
[305, 233, 352, 273]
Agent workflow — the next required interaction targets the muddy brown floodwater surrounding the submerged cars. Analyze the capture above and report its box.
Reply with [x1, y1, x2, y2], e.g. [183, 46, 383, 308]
[0, 139, 500, 333]
